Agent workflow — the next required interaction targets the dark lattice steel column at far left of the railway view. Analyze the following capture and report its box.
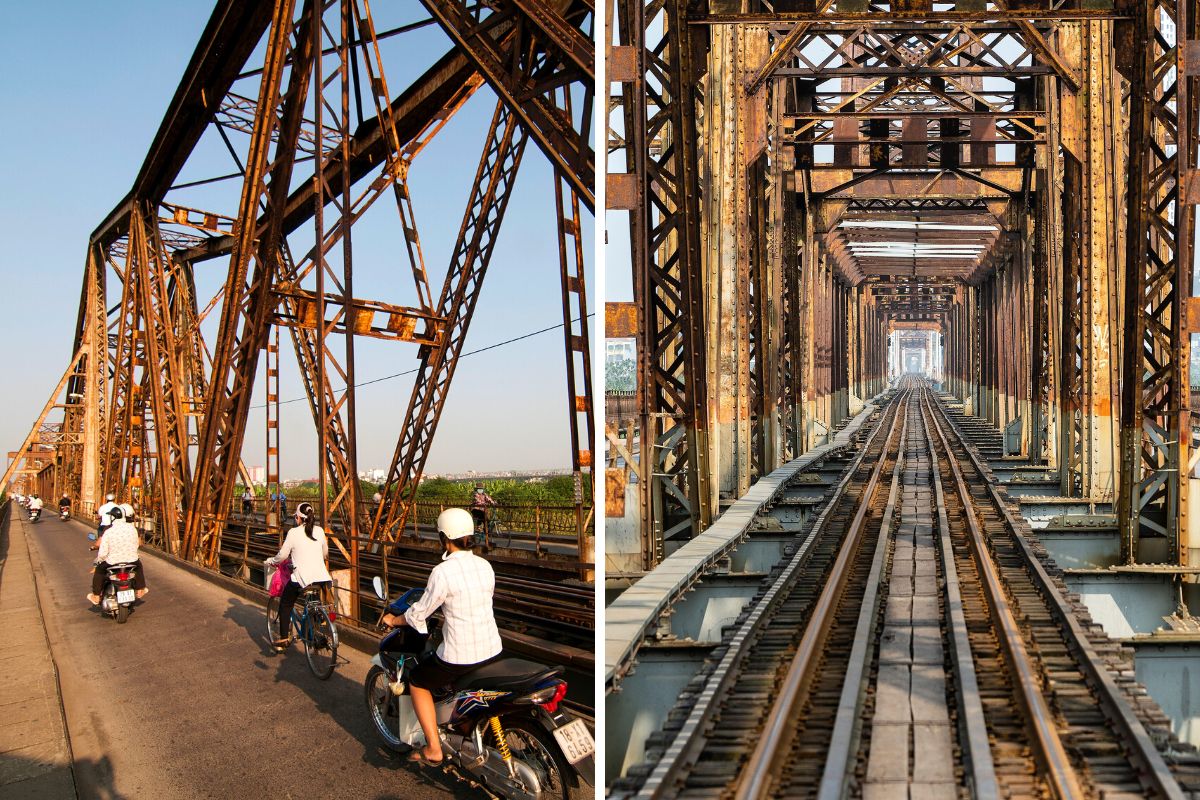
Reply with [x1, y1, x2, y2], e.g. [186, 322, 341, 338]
[608, 0, 714, 554]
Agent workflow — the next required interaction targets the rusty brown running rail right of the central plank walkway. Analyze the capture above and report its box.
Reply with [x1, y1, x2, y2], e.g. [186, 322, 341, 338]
[923, 383, 1085, 800]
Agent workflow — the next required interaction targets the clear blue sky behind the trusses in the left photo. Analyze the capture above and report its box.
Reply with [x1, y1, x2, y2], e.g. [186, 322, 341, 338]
[0, 0, 595, 477]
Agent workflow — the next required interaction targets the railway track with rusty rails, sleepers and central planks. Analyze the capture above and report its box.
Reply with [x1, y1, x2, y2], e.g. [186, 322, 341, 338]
[613, 380, 1200, 800]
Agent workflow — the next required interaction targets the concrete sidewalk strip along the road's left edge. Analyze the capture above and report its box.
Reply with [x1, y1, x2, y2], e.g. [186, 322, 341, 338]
[0, 507, 76, 800]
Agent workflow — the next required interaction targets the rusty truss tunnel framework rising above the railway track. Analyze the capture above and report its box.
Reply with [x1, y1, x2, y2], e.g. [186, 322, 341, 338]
[607, 0, 1200, 581]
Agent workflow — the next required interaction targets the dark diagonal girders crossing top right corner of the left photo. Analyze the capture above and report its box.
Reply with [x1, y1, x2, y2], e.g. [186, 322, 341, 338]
[421, 0, 595, 212]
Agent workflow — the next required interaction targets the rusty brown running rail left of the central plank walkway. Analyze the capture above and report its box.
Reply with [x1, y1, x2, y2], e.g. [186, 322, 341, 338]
[733, 391, 911, 800]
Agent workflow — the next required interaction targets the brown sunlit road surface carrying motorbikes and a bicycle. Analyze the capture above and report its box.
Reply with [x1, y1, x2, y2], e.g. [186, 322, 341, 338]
[24, 509, 468, 800]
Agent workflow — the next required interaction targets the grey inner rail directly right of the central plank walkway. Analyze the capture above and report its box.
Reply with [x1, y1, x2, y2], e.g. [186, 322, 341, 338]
[922, 395, 1000, 800]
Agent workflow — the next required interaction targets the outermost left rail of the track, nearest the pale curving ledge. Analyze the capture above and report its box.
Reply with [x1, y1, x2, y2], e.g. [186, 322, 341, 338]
[636, 391, 896, 800]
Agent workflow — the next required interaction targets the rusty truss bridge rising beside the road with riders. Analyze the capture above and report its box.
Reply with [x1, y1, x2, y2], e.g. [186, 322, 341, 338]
[2, 0, 595, 618]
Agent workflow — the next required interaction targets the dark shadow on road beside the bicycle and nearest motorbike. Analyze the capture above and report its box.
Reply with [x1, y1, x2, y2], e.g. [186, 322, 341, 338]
[224, 597, 472, 800]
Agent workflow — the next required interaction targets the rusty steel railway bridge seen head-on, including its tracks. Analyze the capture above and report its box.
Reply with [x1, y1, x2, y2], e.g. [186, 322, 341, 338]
[604, 0, 1200, 799]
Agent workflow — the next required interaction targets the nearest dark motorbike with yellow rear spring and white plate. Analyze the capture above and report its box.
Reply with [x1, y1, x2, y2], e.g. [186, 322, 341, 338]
[365, 577, 595, 800]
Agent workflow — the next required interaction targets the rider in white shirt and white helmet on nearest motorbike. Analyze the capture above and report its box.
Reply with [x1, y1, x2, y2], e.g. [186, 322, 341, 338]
[383, 509, 502, 765]
